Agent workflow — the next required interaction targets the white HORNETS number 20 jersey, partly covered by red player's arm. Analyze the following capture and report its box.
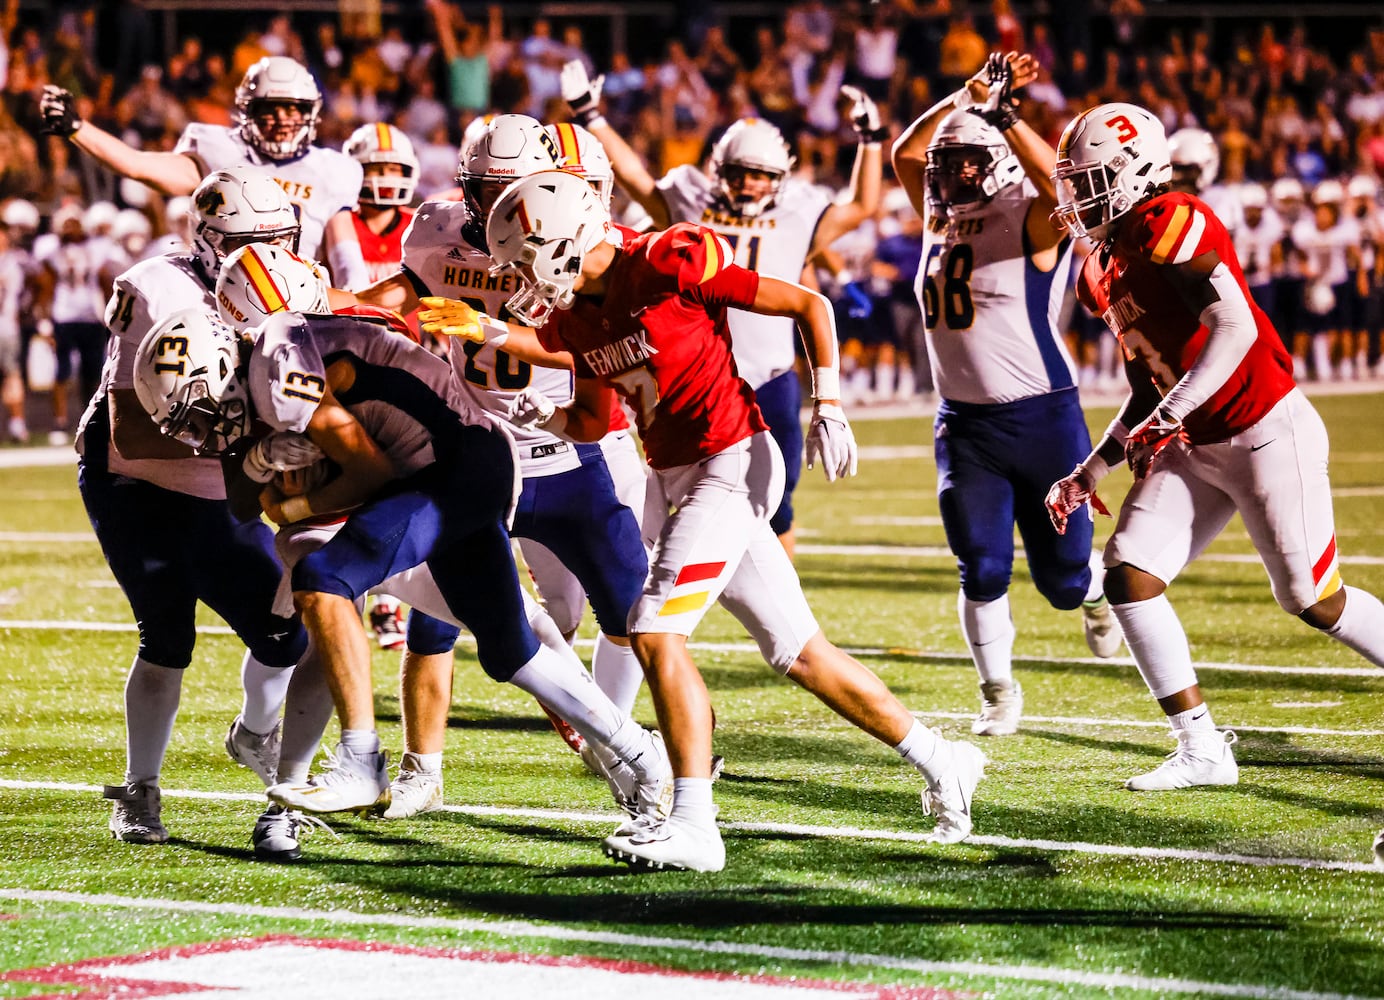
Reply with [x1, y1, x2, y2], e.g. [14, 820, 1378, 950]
[404, 202, 581, 479]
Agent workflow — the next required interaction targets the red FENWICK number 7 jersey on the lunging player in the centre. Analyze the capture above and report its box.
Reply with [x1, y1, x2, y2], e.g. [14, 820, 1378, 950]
[538, 223, 768, 469]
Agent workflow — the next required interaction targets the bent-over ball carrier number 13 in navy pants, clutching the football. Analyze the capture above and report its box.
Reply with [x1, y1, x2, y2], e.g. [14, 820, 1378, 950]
[138, 298, 667, 846]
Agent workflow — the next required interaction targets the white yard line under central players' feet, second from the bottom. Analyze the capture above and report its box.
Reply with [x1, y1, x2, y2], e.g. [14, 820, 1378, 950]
[0, 779, 1384, 876]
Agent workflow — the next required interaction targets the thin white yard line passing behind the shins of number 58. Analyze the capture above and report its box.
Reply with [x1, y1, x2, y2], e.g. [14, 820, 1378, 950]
[0, 616, 1384, 680]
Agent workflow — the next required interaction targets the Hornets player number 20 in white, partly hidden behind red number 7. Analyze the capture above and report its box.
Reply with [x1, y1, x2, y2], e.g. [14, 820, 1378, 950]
[343, 115, 648, 817]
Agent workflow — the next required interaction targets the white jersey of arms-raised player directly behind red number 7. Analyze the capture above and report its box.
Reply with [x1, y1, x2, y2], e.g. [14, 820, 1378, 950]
[659, 166, 832, 389]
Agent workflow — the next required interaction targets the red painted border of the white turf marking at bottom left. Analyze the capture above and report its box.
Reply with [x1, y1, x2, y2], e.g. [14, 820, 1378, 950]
[0, 934, 976, 1000]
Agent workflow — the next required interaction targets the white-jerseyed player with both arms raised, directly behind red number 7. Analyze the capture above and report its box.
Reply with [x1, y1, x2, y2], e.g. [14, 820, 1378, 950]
[562, 59, 889, 556]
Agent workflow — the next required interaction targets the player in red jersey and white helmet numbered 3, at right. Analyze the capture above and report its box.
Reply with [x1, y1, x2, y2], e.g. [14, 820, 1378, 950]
[1048, 104, 1384, 791]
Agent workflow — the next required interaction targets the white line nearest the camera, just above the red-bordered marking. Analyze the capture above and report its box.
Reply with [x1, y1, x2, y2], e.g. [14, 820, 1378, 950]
[0, 888, 1378, 1000]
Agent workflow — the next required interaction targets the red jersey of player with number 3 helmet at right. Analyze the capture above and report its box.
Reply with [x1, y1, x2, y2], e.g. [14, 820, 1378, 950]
[1077, 192, 1294, 444]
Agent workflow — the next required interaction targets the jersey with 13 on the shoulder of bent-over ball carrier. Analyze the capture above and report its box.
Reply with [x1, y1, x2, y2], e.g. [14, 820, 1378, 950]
[248, 313, 491, 477]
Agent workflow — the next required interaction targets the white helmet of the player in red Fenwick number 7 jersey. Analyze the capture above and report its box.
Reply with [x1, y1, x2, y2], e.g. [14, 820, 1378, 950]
[486, 170, 610, 326]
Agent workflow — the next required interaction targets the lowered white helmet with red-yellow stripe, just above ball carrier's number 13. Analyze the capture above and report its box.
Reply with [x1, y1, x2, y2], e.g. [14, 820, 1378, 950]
[216, 243, 332, 331]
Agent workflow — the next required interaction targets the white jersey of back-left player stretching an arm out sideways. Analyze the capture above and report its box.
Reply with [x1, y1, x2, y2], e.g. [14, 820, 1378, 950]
[173, 122, 364, 260]
